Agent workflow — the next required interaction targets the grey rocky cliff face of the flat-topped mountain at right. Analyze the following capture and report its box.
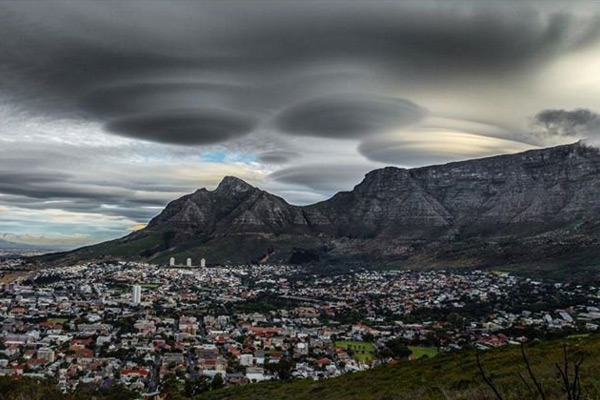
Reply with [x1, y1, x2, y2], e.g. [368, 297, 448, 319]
[310, 144, 600, 238]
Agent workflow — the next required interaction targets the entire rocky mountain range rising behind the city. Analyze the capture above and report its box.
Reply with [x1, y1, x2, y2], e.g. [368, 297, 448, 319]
[38, 143, 600, 278]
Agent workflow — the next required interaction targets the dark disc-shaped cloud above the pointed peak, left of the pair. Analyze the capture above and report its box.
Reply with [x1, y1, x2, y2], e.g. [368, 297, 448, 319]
[107, 110, 255, 145]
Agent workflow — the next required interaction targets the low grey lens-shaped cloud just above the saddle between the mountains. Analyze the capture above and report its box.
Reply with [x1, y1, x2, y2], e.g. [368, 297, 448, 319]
[270, 164, 374, 193]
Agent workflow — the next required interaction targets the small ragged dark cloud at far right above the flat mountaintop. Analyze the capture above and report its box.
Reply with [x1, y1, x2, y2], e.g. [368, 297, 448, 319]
[532, 108, 600, 138]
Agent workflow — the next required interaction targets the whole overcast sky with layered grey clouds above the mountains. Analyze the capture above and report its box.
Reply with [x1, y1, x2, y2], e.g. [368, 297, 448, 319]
[0, 0, 600, 245]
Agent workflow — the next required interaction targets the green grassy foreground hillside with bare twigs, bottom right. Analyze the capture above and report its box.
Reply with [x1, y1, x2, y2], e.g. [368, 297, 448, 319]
[198, 335, 600, 400]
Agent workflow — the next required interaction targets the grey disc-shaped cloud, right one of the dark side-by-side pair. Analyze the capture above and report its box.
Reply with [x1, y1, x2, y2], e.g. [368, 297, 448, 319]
[276, 96, 425, 139]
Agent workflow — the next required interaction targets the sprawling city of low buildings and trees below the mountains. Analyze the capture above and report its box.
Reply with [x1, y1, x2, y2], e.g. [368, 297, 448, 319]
[0, 260, 600, 397]
